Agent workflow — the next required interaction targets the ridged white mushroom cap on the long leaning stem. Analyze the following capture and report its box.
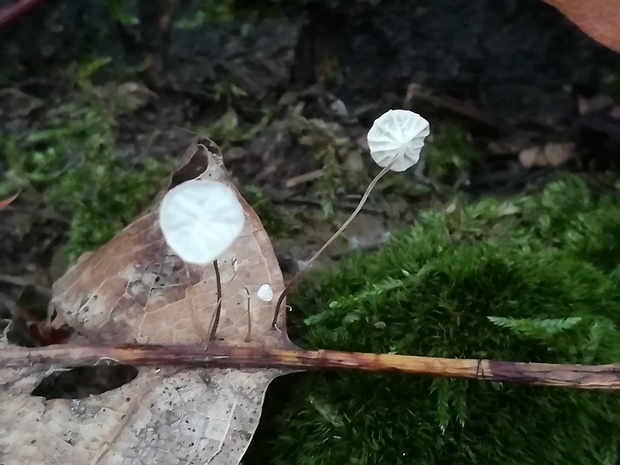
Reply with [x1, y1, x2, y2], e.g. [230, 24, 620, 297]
[367, 110, 430, 171]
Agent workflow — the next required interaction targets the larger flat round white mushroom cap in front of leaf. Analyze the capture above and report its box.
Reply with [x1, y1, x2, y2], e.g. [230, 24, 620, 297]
[159, 179, 245, 265]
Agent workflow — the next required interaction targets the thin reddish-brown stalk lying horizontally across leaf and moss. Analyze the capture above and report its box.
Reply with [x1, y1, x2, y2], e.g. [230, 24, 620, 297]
[0, 345, 620, 390]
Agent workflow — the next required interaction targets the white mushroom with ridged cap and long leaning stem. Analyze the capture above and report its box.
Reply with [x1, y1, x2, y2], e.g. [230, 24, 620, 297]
[273, 110, 430, 326]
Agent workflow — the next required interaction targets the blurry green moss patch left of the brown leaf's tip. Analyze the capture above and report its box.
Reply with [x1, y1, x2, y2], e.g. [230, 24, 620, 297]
[0, 60, 172, 261]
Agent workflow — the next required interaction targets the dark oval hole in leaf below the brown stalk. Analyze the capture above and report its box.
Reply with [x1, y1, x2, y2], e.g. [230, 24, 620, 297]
[31, 363, 138, 399]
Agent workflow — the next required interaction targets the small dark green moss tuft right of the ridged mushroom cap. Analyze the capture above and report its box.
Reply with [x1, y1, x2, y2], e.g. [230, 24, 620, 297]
[425, 125, 482, 184]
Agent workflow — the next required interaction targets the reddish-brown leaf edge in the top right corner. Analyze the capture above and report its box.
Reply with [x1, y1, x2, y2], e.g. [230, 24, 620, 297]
[544, 0, 620, 52]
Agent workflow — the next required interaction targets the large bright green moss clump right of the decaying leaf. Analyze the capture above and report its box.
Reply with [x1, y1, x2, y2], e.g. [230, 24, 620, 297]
[247, 175, 620, 465]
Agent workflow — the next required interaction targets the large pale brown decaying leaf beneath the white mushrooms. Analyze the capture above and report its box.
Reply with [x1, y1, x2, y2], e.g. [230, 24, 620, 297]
[0, 140, 293, 465]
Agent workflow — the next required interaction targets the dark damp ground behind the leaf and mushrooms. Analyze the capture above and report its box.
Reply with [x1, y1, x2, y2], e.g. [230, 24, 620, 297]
[0, 0, 620, 454]
